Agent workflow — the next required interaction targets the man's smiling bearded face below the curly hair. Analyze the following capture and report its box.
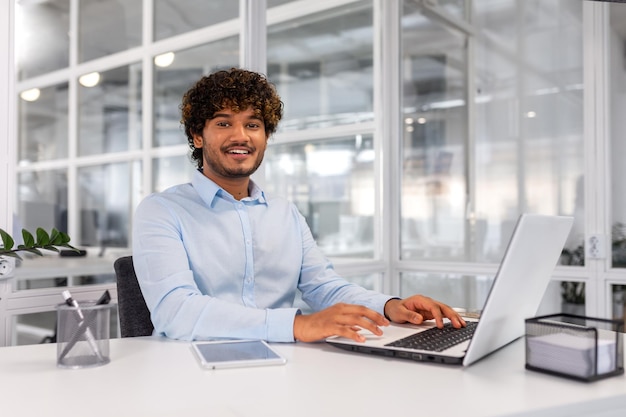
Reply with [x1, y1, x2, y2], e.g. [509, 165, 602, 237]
[193, 108, 267, 187]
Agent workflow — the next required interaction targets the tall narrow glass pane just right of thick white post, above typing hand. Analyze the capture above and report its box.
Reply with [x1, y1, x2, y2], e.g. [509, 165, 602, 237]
[401, 3, 467, 259]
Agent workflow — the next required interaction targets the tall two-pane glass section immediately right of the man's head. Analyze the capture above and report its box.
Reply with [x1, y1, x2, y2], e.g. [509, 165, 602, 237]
[265, 1, 377, 259]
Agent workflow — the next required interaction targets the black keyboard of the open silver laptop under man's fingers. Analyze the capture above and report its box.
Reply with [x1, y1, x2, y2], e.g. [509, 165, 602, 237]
[385, 321, 478, 352]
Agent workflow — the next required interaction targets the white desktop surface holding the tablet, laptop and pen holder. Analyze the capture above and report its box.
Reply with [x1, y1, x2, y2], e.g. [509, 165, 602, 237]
[0, 337, 626, 417]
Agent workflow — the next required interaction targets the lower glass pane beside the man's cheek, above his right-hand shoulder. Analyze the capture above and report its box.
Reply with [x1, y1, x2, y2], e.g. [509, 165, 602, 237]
[264, 135, 375, 258]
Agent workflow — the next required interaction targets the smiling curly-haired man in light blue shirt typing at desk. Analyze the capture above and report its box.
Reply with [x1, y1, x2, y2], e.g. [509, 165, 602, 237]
[133, 68, 465, 342]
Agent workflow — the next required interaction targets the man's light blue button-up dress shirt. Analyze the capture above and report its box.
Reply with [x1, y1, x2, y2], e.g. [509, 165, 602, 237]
[133, 171, 391, 342]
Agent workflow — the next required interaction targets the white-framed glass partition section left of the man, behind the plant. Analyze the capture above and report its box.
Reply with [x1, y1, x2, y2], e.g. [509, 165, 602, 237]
[8, 0, 241, 344]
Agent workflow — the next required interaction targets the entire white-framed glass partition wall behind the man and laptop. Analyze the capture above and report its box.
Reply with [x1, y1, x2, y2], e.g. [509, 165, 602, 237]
[7, 0, 626, 344]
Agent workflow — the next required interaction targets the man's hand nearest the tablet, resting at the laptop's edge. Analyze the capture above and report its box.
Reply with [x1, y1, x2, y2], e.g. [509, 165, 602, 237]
[293, 303, 389, 342]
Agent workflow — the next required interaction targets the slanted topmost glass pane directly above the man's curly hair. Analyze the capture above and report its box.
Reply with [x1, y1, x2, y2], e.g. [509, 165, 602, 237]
[154, 0, 239, 41]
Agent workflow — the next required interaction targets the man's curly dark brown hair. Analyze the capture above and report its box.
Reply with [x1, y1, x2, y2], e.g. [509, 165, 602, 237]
[180, 68, 283, 168]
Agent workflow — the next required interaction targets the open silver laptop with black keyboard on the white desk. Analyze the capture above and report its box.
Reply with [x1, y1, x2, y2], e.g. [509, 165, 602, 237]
[326, 214, 574, 366]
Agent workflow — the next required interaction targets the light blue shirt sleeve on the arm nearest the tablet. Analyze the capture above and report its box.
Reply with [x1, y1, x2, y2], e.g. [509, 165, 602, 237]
[133, 196, 298, 342]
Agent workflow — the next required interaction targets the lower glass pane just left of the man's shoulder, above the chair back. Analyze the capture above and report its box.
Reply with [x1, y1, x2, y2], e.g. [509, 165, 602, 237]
[77, 162, 141, 250]
